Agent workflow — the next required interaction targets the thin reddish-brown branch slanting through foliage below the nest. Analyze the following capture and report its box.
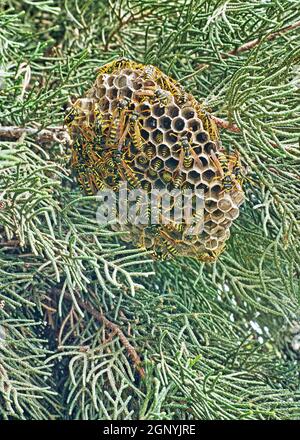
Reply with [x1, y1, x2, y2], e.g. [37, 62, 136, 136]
[52, 289, 145, 378]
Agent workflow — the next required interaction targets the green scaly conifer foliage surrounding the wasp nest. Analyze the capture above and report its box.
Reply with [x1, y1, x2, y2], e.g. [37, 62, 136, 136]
[0, 0, 300, 420]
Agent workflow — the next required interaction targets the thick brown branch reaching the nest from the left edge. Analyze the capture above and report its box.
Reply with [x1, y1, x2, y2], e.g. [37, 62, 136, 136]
[0, 126, 70, 143]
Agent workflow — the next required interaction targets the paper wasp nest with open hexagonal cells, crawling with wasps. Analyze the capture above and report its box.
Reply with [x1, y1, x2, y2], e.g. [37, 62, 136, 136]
[65, 59, 244, 261]
